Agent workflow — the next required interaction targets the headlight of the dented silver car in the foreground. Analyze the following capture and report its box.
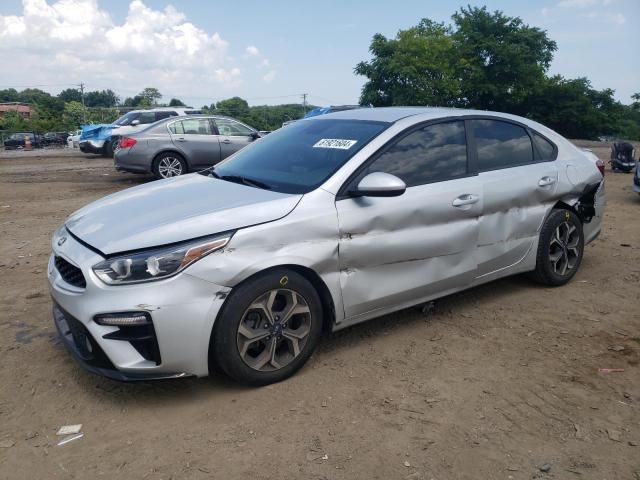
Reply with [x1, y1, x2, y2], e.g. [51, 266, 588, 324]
[93, 233, 232, 285]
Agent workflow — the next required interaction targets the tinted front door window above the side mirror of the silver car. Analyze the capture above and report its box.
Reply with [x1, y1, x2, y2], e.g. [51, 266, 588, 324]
[359, 121, 468, 187]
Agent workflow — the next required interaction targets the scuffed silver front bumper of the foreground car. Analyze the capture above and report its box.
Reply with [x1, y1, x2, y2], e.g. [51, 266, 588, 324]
[48, 231, 230, 381]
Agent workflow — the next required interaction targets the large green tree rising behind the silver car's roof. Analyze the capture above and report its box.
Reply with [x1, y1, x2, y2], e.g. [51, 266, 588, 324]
[355, 7, 556, 111]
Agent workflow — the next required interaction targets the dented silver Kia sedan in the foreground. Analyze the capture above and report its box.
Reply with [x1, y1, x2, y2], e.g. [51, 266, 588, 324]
[48, 108, 605, 385]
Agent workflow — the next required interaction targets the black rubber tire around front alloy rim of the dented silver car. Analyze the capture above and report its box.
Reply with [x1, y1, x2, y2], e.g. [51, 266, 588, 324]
[209, 268, 323, 386]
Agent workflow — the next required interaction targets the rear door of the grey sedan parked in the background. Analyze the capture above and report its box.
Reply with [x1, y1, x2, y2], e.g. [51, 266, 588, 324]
[168, 118, 220, 168]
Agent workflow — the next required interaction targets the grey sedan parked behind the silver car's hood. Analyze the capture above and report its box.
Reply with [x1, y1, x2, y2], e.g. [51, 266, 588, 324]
[114, 115, 262, 178]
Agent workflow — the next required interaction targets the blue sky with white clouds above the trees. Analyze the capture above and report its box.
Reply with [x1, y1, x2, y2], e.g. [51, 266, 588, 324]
[0, 0, 640, 107]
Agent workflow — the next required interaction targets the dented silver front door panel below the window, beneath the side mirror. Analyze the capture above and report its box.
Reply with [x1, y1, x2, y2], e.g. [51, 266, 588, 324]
[336, 177, 482, 318]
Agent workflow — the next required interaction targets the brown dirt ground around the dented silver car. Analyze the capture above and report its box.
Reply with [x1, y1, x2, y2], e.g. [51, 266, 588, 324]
[0, 144, 640, 480]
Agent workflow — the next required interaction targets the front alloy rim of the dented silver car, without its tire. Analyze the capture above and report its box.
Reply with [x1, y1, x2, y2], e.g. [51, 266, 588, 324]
[236, 288, 312, 372]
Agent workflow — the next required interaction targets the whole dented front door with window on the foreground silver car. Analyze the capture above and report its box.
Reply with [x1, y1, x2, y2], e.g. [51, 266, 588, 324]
[336, 120, 482, 318]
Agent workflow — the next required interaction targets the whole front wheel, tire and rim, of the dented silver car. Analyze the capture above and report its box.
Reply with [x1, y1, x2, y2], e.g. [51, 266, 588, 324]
[210, 269, 322, 386]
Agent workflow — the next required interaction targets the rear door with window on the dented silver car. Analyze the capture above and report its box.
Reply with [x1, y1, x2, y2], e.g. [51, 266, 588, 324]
[470, 118, 558, 279]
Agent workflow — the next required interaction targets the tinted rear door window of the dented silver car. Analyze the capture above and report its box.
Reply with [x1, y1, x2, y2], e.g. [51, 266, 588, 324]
[471, 120, 533, 172]
